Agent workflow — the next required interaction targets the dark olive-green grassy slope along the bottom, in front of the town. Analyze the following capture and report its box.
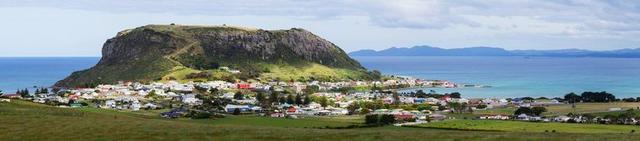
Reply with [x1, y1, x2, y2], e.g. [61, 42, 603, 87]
[0, 101, 640, 141]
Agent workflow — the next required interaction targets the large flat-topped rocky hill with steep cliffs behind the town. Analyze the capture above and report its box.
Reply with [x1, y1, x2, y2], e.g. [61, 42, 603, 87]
[56, 25, 366, 87]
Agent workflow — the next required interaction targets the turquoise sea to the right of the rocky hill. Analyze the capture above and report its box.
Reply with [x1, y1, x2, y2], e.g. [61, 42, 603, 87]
[354, 56, 640, 97]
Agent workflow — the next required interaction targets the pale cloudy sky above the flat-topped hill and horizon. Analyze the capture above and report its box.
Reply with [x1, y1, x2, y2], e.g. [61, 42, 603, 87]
[0, 0, 640, 56]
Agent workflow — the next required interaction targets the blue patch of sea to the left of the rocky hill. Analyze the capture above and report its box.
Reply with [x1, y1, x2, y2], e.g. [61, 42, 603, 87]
[0, 57, 100, 93]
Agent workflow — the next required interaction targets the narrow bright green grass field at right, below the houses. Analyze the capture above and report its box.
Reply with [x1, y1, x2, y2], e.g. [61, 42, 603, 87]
[419, 120, 640, 133]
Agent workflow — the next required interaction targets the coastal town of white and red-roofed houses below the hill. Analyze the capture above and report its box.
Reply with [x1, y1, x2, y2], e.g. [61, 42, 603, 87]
[2, 77, 640, 126]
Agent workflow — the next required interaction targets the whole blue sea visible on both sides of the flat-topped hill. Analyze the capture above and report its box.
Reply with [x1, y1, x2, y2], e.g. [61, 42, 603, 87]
[0, 56, 640, 98]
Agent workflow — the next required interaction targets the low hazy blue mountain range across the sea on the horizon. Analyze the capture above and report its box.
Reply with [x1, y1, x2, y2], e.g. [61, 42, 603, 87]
[349, 46, 640, 58]
